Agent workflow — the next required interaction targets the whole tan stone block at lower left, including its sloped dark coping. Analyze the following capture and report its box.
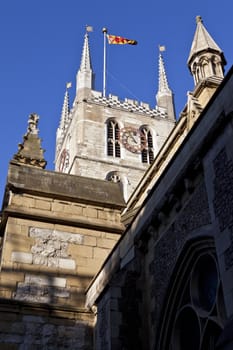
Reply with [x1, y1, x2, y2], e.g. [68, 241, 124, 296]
[0, 163, 124, 350]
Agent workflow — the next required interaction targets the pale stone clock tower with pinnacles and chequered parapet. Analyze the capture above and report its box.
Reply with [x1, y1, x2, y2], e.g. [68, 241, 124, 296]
[55, 29, 175, 200]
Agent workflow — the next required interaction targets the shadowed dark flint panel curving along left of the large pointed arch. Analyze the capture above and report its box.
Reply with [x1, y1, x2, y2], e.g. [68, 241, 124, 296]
[149, 182, 211, 342]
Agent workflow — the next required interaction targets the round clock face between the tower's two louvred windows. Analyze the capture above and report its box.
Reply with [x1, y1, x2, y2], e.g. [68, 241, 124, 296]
[120, 127, 146, 153]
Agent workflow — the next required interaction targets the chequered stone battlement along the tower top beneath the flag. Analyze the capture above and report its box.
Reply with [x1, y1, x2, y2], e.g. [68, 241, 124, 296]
[87, 90, 168, 118]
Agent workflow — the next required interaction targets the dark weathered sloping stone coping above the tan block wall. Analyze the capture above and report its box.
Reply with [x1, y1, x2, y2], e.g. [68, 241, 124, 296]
[7, 161, 126, 209]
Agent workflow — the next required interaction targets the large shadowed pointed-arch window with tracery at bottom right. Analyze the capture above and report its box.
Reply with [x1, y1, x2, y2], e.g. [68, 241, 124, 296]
[156, 237, 226, 350]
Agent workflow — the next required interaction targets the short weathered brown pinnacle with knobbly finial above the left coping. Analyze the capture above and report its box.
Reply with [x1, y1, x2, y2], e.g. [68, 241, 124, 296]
[13, 113, 47, 169]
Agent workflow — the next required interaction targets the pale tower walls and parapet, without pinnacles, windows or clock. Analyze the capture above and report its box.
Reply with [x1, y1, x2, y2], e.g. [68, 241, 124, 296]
[56, 98, 175, 199]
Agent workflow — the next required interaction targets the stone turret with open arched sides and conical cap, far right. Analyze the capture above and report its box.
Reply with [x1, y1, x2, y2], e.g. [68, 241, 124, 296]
[188, 16, 226, 85]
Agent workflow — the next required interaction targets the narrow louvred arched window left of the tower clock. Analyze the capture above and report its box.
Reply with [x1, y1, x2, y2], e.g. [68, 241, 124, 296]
[107, 120, 121, 158]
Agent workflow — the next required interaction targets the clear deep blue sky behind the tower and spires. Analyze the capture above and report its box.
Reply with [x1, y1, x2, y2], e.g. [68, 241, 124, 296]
[0, 0, 233, 202]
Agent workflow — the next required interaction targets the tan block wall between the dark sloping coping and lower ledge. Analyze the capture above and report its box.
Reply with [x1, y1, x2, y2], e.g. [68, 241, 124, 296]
[0, 194, 122, 306]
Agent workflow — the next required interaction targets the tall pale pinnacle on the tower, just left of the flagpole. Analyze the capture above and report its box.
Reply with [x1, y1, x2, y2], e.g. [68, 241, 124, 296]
[76, 32, 94, 100]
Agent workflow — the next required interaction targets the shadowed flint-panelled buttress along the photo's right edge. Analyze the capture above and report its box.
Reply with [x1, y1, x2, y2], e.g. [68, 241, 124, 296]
[205, 119, 233, 318]
